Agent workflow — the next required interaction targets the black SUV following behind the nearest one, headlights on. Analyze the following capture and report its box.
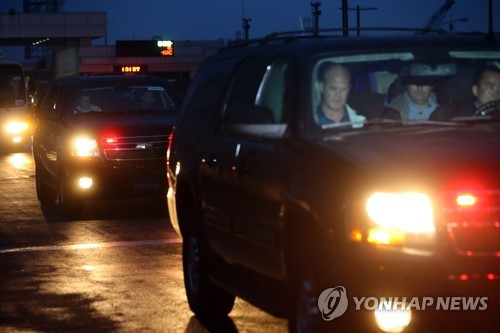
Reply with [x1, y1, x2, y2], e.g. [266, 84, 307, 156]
[33, 76, 178, 217]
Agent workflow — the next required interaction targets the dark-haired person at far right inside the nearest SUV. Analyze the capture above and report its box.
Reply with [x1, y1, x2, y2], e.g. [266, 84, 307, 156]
[429, 66, 500, 120]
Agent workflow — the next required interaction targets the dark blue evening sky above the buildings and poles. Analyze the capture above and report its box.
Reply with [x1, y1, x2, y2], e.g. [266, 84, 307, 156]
[0, 0, 500, 58]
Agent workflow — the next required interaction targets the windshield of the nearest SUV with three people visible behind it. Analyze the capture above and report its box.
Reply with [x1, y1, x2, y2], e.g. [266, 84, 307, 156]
[311, 49, 500, 129]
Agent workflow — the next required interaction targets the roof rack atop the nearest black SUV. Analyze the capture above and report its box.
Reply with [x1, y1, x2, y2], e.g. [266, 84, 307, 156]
[222, 27, 450, 49]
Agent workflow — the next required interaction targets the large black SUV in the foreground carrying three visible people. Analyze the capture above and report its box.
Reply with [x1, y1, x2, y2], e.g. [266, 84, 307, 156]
[167, 34, 500, 332]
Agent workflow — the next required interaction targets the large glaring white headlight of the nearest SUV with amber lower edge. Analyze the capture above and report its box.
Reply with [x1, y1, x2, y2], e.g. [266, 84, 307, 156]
[366, 192, 436, 244]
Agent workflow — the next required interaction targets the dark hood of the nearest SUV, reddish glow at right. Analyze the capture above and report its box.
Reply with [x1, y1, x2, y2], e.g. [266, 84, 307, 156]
[320, 127, 500, 188]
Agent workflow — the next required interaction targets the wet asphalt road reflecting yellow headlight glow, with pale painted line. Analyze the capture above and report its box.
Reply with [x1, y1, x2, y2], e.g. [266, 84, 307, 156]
[0, 152, 286, 332]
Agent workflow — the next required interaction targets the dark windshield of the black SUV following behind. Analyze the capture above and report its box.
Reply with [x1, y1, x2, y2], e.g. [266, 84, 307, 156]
[72, 85, 175, 114]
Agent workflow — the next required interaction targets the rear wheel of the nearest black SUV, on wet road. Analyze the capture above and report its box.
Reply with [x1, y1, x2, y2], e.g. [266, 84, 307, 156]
[182, 219, 235, 317]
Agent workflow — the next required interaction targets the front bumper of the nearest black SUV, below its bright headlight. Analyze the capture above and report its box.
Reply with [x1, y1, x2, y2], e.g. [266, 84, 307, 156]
[325, 244, 500, 332]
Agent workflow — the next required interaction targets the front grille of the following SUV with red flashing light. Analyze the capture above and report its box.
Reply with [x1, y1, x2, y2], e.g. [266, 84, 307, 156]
[101, 135, 168, 161]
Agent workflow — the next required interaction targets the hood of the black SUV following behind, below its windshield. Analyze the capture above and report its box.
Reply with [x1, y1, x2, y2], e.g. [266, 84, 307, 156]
[67, 114, 175, 137]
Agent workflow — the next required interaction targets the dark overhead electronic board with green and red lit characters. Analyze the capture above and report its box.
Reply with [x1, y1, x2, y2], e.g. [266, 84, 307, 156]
[116, 40, 174, 57]
